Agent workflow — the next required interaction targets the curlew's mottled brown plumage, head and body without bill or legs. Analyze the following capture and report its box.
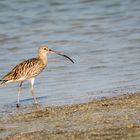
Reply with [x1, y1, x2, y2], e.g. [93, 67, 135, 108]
[2, 46, 49, 83]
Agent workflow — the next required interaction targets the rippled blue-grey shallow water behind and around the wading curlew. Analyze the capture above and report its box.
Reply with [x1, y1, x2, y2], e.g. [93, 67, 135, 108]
[0, 0, 140, 112]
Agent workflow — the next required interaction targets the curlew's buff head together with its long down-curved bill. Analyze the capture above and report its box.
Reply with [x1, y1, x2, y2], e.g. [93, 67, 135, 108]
[39, 45, 74, 63]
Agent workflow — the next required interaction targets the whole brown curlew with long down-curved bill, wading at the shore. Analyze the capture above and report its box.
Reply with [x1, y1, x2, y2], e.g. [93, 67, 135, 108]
[0, 45, 74, 107]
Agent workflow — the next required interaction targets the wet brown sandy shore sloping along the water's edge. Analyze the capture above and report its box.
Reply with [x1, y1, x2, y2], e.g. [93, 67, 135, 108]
[0, 93, 140, 140]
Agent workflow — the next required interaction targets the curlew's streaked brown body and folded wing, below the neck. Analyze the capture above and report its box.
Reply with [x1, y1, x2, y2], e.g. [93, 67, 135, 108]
[2, 58, 46, 83]
